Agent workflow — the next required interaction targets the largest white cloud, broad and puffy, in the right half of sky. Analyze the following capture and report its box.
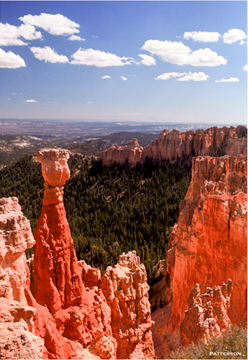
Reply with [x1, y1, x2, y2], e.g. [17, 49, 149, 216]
[142, 40, 227, 66]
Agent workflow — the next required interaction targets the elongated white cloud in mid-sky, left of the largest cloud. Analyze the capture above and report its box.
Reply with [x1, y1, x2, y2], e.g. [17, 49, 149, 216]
[71, 48, 133, 67]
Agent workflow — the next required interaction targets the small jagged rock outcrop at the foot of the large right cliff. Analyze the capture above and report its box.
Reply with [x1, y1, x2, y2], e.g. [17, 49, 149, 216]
[180, 279, 232, 345]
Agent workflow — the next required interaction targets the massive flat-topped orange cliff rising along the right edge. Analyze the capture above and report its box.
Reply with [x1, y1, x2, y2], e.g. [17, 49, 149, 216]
[153, 156, 247, 357]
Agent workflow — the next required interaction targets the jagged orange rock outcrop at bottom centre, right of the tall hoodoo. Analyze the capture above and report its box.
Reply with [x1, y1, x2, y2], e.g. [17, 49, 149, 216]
[100, 251, 155, 359]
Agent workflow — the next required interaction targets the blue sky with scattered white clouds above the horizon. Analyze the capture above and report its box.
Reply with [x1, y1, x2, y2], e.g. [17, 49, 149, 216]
[0, 1, 247, 124]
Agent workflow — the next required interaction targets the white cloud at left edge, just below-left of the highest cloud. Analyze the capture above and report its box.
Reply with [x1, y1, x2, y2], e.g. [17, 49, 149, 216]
[0, 23, 42, 46]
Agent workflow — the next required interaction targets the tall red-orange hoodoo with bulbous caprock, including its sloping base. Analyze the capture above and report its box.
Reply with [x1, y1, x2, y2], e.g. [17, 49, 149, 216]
[34, 149, 116, 359]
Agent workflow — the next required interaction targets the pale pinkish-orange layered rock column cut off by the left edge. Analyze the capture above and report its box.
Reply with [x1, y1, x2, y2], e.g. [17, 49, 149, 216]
[0, 197, 43, 359]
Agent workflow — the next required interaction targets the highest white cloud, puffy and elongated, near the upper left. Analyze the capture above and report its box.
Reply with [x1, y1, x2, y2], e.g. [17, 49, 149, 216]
[19, 13, 80, 36]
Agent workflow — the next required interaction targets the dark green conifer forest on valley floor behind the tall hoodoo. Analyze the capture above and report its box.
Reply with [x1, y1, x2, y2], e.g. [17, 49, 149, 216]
[0, 155, 191, 283]
